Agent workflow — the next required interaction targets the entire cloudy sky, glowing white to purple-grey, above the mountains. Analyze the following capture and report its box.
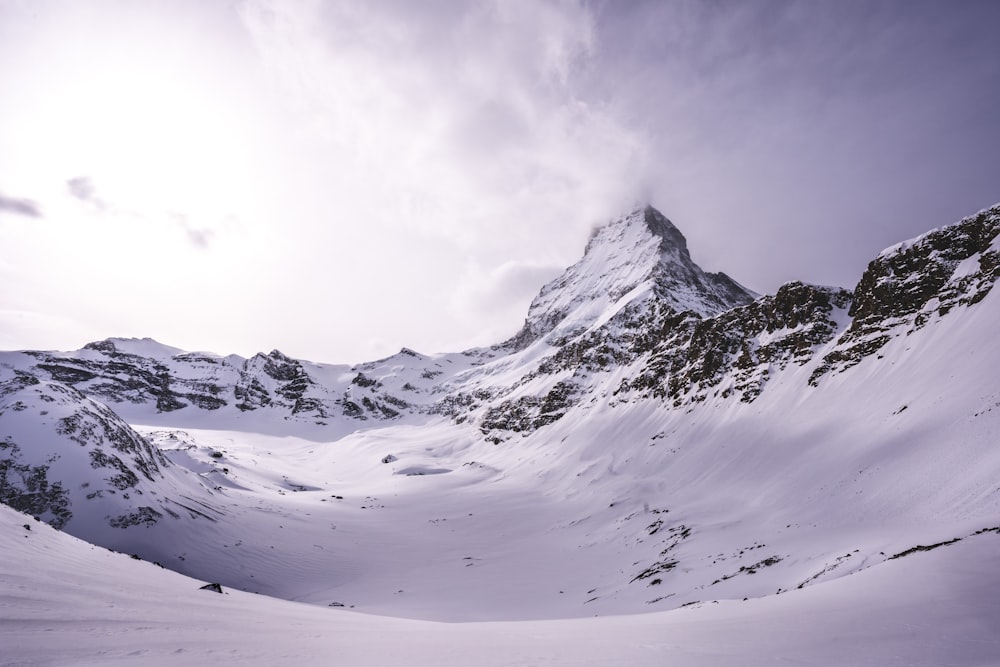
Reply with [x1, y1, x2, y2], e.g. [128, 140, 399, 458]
[0, 0, 1000, 362]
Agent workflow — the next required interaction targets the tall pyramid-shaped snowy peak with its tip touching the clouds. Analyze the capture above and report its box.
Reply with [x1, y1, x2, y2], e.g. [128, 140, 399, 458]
[511, 206, 756, 347]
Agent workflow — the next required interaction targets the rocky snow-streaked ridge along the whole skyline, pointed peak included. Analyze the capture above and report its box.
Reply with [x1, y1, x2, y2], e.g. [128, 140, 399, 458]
[8, 201, 1000, 439]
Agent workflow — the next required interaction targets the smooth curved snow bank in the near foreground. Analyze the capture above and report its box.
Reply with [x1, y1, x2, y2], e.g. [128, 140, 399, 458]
[0, 507, 1000, 667]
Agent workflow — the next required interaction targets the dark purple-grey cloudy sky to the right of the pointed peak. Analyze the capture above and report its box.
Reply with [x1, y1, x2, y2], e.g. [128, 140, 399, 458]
[583, 0, 1000, 291]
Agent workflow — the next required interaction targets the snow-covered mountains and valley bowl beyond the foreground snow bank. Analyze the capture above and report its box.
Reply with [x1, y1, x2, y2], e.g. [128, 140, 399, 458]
[0, 205, 1000, 664]
